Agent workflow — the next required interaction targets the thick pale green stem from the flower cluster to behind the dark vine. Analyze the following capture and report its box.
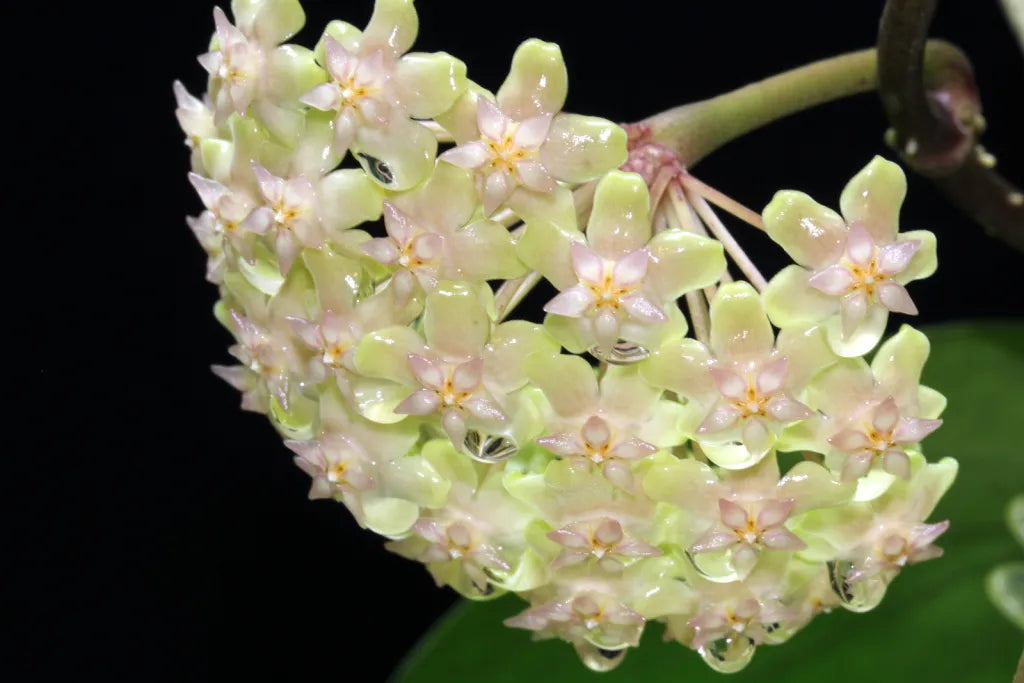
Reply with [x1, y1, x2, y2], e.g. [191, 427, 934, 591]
[640, 41, 970, 166]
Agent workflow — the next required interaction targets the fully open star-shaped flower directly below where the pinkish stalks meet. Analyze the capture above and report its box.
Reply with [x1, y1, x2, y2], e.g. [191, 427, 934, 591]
[517, 171, 725, 356]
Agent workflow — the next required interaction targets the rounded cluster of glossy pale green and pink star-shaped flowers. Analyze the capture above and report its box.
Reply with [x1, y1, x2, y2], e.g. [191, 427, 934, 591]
[175, 0, 956, 671]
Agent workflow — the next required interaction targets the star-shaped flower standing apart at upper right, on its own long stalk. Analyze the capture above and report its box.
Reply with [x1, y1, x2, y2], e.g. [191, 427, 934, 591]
[764, 157, 936, 357]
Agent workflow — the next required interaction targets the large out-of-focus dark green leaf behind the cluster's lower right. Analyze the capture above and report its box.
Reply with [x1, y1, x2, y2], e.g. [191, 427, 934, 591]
[392, 322, 1024, 683]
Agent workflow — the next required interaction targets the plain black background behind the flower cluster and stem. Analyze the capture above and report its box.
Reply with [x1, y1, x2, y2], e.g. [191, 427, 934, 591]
[12, 0, 1024, 681]
